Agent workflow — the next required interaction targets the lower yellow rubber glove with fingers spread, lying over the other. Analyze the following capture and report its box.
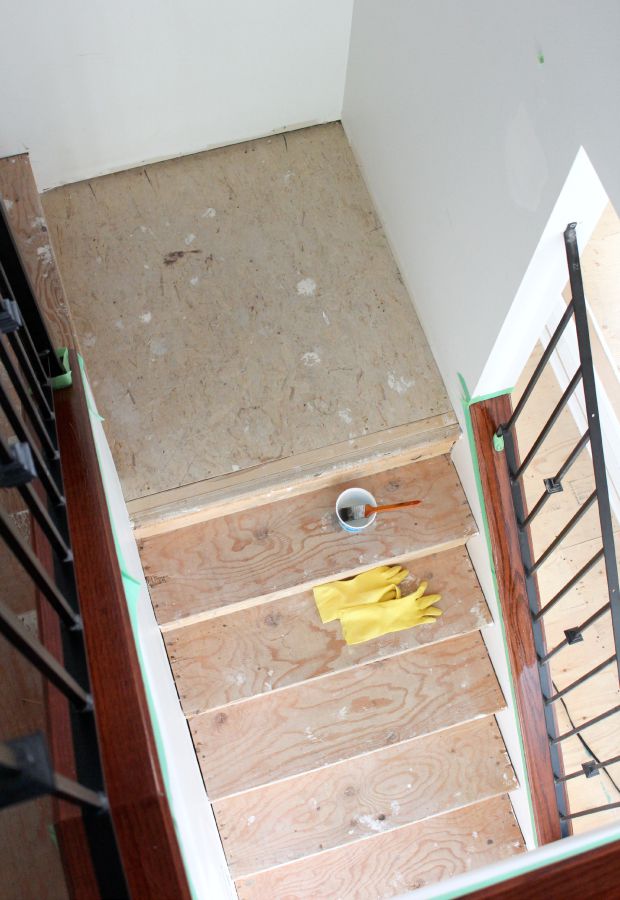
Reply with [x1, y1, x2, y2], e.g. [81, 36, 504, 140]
[340, 581, 441, 644]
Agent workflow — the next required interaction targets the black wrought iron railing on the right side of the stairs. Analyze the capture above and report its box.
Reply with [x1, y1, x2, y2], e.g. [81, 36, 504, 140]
[496, 223, 620, 835]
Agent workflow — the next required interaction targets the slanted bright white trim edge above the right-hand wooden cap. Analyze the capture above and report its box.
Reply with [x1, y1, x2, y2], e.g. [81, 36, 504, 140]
[473, 147, 609, 397]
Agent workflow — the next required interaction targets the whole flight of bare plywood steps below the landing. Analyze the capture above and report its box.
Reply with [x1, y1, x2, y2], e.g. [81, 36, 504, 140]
[140, 455, 524, 900]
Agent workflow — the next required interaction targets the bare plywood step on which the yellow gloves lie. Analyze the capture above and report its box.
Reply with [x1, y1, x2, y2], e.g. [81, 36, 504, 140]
[164, 547, 490, 716]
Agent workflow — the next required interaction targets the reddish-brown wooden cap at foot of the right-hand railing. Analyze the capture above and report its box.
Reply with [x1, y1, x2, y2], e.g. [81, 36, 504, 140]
[470, 396, 560, 844]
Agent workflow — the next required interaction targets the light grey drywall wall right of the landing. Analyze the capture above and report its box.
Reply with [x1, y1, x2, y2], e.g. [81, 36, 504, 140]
[343, 0, 620, 412]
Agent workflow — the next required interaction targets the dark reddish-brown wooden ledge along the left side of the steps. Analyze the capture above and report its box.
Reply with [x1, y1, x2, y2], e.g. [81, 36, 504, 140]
[55, 351, 190, 900]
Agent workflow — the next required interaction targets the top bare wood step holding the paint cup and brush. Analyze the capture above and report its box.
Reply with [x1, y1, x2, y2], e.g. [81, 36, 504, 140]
[141, 456, 474, 625]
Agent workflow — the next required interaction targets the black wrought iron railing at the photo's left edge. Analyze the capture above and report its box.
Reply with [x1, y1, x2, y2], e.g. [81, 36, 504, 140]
[0, 206, 129, 897]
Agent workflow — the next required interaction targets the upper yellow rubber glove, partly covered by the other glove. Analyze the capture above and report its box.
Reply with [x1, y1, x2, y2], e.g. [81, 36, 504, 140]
[314, 566, 409, 622]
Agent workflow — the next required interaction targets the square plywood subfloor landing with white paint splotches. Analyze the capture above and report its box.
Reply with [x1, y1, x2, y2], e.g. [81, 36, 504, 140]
[43, 124, 452, 499]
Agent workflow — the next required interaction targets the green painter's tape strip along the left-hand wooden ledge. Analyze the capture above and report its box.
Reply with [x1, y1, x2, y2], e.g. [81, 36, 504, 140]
[78, 364, 199, 900]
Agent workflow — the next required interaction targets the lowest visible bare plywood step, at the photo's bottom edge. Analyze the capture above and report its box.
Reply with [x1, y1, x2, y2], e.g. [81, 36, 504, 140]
[236, 796, 525, 900]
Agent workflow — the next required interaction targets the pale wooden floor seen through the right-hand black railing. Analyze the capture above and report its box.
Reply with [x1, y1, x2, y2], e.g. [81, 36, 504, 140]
[513, 200, 620, 833]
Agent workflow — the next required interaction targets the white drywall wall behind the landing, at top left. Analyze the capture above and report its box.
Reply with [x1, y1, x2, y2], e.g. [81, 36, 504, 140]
[0, 0, 353, 190]
